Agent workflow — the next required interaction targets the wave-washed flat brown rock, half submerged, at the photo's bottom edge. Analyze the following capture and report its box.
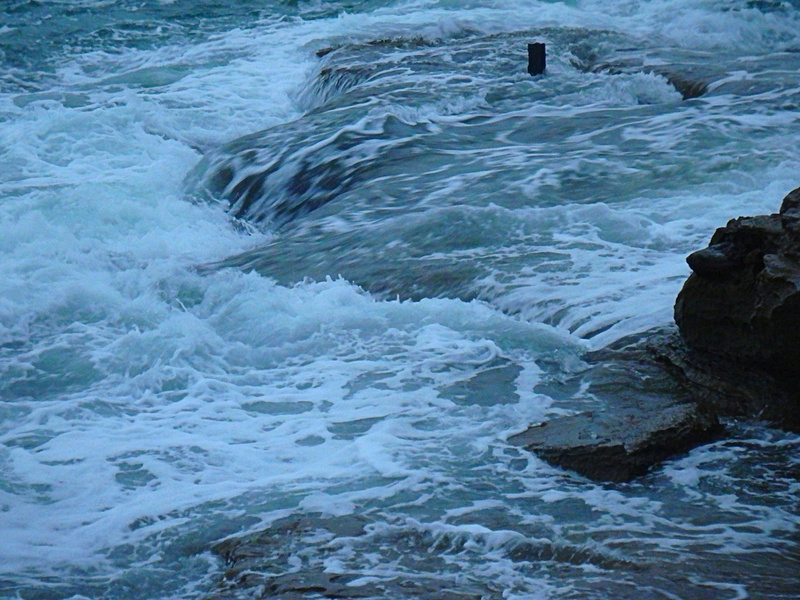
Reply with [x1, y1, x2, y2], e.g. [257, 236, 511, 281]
[204, 510, 647, 600]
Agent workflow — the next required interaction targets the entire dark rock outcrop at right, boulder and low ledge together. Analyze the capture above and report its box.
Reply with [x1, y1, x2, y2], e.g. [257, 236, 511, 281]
[509, 188, 800, 481]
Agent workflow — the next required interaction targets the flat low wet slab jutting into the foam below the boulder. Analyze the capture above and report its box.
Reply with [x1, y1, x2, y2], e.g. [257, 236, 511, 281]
[509, 331, 723, 482]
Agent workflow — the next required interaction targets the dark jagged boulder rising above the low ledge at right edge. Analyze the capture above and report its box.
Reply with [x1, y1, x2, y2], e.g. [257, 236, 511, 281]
[675, 188, 800, 392]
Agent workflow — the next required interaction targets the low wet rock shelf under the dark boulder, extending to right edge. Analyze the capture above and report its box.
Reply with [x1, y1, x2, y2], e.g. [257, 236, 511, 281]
[509, 328, 800, 482]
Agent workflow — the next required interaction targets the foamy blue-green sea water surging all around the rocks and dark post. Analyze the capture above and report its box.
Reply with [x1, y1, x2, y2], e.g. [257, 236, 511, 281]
[0, 0, 800, 600]
